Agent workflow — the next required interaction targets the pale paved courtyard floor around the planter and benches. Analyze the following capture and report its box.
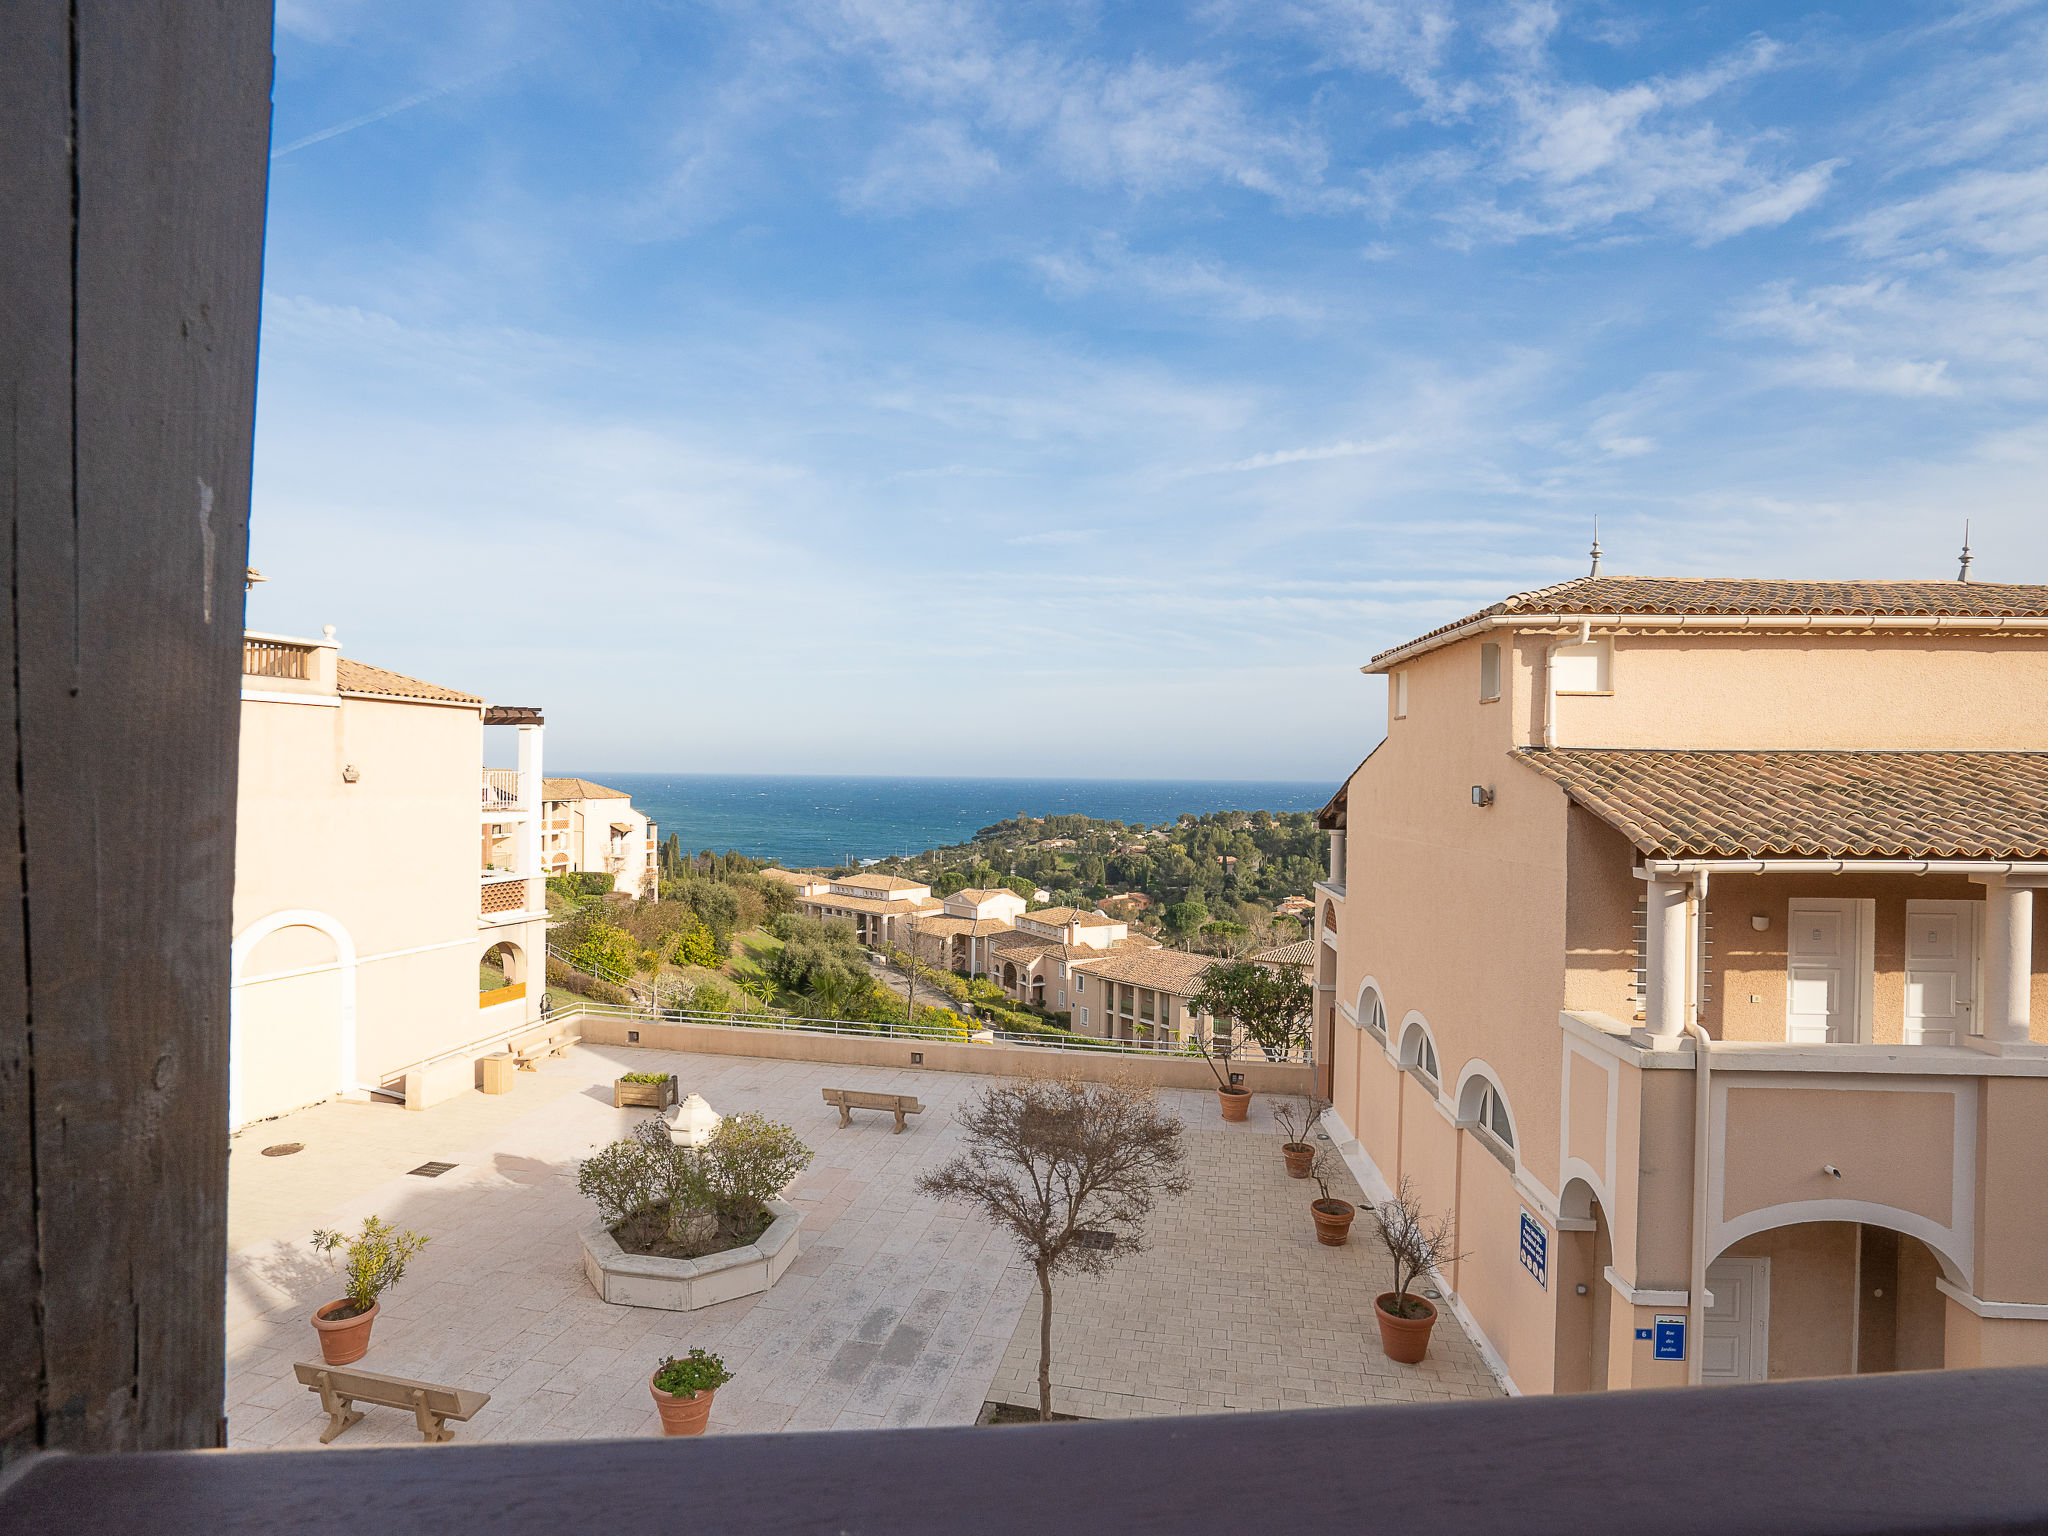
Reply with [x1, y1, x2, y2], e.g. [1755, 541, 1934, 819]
[227, 1047, 1499, 1446]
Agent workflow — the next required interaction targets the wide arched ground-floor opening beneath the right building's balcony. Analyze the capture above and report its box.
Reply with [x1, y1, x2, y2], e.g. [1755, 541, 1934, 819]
[1700, 1221, 1960, 1382]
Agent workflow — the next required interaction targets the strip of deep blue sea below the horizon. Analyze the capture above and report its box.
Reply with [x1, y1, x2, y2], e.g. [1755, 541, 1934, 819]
[551, 764, 1337, 868]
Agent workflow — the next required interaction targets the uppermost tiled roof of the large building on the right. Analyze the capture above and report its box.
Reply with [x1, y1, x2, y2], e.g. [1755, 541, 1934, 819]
[1372, 575, 2048, 664]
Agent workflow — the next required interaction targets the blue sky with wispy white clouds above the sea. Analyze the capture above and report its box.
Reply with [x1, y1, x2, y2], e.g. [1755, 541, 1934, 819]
[250, 0, 2048, 778]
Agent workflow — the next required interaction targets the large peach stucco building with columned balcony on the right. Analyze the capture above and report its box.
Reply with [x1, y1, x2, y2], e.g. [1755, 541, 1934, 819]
[1315, 575, 2048, 1393]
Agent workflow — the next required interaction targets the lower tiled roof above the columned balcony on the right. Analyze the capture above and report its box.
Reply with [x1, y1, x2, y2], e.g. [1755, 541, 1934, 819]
[1516, 748, 2048, 858]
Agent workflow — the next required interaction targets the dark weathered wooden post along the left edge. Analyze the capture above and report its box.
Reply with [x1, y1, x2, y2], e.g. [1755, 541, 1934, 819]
[0, 0, 270, 1464]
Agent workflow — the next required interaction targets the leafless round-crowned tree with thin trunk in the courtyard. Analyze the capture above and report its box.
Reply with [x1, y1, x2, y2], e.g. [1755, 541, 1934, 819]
[918, 1077, 1192, 1421]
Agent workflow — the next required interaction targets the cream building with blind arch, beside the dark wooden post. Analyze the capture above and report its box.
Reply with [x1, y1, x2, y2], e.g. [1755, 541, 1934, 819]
[227, 627, 547, 1126]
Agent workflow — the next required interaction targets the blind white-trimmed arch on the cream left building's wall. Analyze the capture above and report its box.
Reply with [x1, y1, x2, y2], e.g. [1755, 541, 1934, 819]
[227, 909, 356, 1126]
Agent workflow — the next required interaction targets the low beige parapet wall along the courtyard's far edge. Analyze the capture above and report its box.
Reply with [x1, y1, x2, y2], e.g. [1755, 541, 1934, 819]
[555, 1012, 1311, 1094]
